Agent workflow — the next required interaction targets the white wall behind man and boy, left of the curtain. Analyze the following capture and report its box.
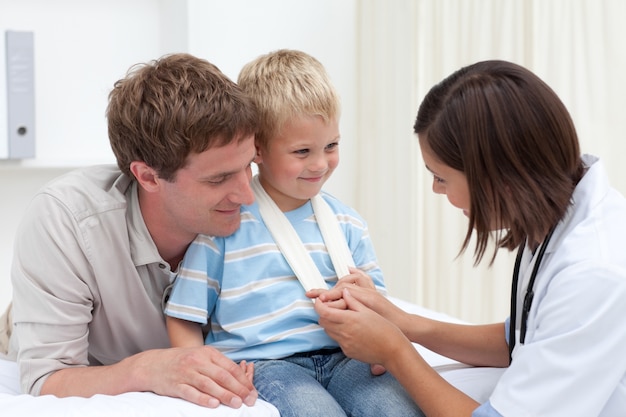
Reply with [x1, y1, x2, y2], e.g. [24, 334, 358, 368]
[0, 0, 356, 309]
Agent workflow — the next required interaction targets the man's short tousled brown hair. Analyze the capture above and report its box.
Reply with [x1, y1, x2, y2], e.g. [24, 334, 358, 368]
[107, 54, 258, 181]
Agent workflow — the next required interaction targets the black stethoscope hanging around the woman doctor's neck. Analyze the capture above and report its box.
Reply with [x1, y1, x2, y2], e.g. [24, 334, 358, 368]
[509, 226, 556, 363]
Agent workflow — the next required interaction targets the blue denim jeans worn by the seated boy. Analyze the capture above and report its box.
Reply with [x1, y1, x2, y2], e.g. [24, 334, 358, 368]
[254, 350, 424, 417]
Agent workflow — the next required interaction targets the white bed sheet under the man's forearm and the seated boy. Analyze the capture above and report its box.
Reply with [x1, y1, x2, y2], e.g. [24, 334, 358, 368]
[0, 298, 503, 417]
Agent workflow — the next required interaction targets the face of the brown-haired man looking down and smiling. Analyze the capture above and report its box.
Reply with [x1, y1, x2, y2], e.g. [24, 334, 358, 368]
[161, 135, 255, 239]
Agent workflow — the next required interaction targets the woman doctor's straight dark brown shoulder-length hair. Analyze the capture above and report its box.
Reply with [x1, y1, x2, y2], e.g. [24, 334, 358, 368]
[414, 61, 583, 264]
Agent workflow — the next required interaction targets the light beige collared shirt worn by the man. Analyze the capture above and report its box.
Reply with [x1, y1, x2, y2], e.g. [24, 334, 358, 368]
[10, 166, 173, 395]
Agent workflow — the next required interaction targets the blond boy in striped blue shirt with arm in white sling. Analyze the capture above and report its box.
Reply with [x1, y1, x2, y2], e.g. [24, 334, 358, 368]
[166, 50, 421, 417]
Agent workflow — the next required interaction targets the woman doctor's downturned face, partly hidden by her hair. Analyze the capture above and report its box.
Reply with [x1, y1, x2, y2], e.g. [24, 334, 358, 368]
[419, 136, 470, 216]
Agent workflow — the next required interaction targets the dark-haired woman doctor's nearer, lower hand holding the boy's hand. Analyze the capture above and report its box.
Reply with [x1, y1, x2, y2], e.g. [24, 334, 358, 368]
[315, 289, 413, 368]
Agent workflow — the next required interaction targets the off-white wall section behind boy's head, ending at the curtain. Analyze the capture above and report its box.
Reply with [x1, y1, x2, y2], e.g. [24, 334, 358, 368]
[182, 0, 358, 205]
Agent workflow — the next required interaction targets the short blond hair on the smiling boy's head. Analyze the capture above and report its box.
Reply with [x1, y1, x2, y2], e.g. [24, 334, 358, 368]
[237, 49, 340, 147]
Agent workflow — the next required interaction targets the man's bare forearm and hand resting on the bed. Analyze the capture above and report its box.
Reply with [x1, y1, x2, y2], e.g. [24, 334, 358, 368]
[41, 346, 258, 408]
